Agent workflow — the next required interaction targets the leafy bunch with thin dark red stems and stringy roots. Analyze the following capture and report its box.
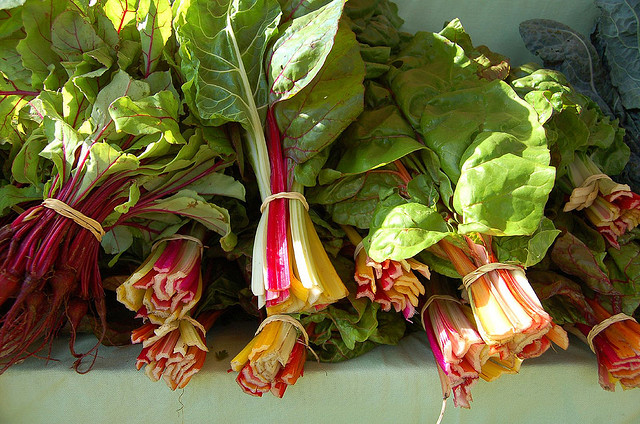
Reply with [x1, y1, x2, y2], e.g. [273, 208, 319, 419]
[0, 0, 244, 370]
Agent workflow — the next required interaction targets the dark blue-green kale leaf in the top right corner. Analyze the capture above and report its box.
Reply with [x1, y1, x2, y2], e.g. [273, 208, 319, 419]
[596, 0, 640, 110]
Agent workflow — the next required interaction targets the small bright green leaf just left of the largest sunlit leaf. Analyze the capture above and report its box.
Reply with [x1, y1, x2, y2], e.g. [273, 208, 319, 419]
[363, 195, 450, 262]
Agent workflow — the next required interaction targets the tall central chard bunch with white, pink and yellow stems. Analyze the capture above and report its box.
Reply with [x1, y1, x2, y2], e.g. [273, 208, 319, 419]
[175, 0, 364, 313]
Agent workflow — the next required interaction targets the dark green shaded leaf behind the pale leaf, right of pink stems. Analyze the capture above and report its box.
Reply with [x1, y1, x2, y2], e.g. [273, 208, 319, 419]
[274, 25, 364, 182]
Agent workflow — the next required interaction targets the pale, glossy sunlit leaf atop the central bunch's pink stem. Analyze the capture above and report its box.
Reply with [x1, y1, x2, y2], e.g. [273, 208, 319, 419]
[267, 0, 345, 103]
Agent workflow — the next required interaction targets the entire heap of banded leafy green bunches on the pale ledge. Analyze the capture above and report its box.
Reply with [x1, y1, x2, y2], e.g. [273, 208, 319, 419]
[0, 0, 640, 418]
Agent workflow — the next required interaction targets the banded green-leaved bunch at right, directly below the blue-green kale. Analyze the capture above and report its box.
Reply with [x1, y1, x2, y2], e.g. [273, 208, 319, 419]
[511, 65, 640, 248]
